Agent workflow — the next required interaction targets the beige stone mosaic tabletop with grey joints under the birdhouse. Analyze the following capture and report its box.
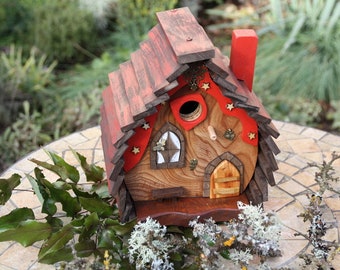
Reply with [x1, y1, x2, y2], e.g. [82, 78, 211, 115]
[0, 121, 340, 270]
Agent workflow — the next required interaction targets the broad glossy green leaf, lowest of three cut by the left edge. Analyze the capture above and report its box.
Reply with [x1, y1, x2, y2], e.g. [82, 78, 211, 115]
[0, 220, 51, 247]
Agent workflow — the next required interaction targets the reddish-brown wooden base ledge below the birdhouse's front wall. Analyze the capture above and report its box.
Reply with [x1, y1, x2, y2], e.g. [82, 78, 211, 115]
[135, 194, 249, 227]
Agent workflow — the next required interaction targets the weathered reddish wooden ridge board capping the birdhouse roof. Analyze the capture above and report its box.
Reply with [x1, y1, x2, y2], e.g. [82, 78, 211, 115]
[157, 7, 215, 64]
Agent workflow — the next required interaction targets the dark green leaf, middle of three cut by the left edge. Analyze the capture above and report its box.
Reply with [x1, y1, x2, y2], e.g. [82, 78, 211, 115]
[0, 207, 35, 232]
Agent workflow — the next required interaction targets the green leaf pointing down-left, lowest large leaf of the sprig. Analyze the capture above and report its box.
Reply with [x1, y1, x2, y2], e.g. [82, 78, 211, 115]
[38, 224, 74, 263]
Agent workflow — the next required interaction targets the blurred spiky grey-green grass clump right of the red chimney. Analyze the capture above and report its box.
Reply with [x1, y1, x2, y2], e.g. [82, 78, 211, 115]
[255, 0, 340, 103]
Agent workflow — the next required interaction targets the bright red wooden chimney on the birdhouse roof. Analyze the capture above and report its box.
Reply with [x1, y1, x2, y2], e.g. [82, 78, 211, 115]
[230, 29, 257, 91]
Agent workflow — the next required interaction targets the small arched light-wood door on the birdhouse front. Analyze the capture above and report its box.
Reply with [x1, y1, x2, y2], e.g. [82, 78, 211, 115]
[210, 160, 241, 198]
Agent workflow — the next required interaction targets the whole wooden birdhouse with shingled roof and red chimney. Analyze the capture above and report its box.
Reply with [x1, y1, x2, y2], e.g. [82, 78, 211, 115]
[101, 8, 279, 226]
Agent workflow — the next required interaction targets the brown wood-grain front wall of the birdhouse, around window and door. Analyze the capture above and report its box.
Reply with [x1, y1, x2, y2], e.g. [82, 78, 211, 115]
[125, 90, 257, 201]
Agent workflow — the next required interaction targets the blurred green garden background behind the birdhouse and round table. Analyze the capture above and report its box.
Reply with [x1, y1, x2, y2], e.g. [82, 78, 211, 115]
[0, 0, 340, 172]
